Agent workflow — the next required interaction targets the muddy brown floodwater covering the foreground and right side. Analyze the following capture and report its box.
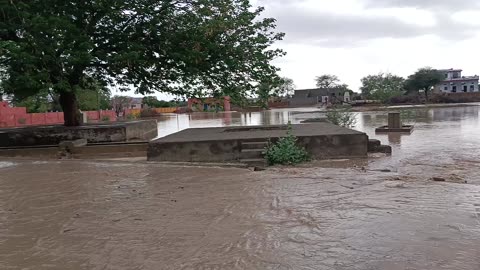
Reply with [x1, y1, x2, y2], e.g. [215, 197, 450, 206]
[0, 107, 480, 270]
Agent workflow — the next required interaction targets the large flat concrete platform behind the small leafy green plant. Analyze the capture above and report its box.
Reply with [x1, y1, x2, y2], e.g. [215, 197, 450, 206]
[147, 123, 368, 162]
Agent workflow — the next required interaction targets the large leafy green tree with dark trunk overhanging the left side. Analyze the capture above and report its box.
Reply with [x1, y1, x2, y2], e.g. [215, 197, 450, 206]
[0, 0, 284, 126]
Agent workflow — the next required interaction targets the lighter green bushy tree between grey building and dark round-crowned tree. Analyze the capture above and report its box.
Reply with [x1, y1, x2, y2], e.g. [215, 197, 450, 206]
[360, 73, 405, 103]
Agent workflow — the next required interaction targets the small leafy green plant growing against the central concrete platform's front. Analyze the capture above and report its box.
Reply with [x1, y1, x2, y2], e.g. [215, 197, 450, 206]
[265, 123, 310, 166]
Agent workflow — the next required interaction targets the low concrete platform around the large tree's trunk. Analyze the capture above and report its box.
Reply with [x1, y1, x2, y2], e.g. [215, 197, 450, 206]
[0, 120, 158, 147]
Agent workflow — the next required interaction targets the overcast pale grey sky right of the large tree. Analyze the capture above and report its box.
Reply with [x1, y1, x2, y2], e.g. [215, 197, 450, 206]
[124, 0, 480, 97]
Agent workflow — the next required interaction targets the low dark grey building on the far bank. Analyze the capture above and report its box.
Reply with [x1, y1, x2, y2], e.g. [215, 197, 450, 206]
[290, 88, 350, 107]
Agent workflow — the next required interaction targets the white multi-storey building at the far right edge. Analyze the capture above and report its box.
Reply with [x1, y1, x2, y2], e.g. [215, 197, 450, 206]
[434, 68, 479, 94]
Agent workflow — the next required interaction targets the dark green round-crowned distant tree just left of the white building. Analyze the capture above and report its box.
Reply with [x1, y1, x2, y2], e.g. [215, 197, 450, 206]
[405, 67, 444, 101]
